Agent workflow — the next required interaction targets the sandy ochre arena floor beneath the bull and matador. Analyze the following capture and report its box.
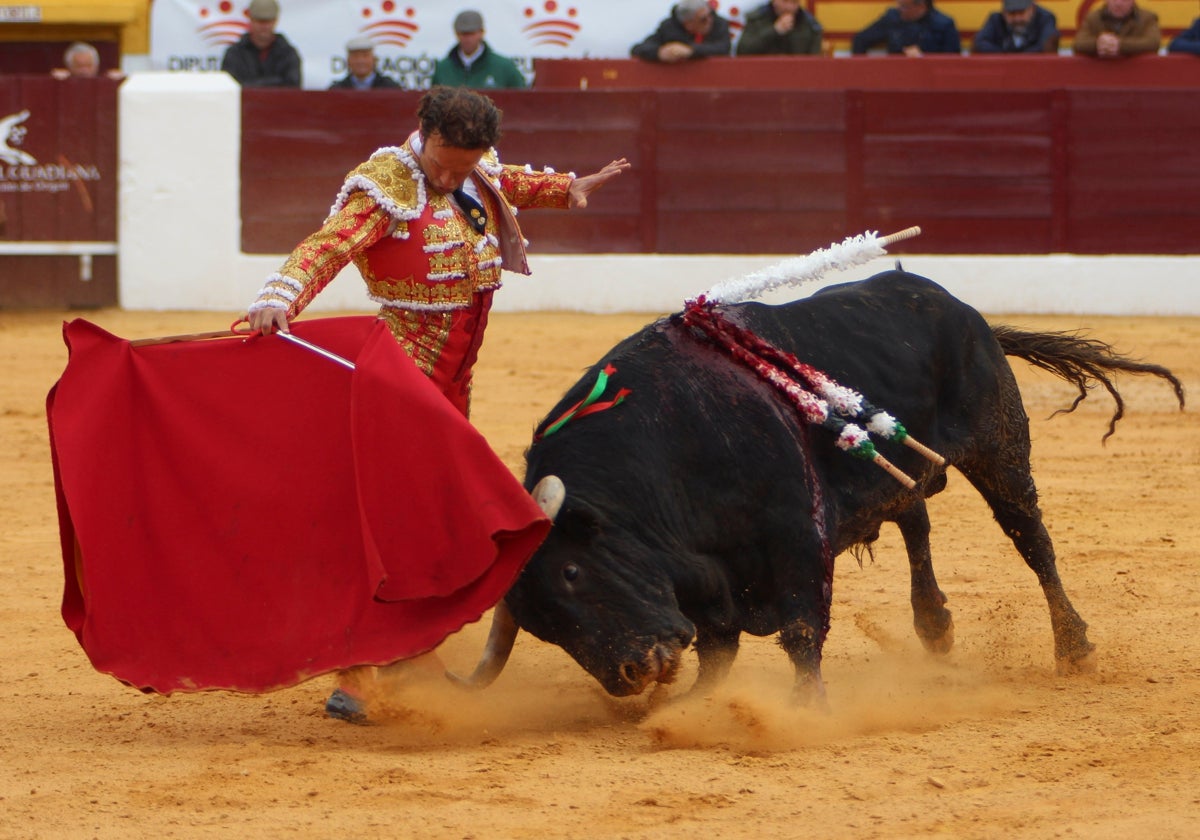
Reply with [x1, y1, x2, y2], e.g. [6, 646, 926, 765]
[0, 298, 1200, 840]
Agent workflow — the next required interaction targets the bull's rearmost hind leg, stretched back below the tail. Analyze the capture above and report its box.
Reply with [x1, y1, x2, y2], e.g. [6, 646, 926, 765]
[959, 456, 1096, 673]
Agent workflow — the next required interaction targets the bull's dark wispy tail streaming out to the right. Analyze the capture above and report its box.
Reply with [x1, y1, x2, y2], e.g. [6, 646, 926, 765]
[991, 326, 1183, 440]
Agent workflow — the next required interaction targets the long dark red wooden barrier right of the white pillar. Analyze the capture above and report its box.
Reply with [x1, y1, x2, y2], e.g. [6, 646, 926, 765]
[242, 56, 1200, 254]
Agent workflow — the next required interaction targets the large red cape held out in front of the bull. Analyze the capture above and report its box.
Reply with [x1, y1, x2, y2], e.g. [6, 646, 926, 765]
[47, 316, 550, 694]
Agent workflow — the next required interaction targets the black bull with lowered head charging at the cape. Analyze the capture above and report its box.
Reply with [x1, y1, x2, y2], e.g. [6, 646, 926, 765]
[453, 271, 1183, 696]
